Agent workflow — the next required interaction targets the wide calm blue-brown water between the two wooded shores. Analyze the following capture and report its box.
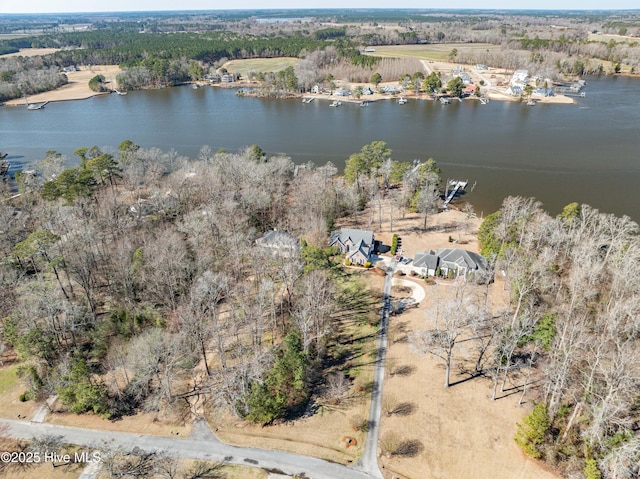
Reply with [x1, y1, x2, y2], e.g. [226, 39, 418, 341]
[0, 77, 640, 221]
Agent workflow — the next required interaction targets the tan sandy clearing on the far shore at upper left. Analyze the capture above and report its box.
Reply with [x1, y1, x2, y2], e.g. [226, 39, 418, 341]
[5, 65, 120, 106]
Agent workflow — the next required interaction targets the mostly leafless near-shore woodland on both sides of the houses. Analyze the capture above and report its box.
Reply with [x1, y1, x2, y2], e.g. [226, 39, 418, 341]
[0, 140, 640, 479]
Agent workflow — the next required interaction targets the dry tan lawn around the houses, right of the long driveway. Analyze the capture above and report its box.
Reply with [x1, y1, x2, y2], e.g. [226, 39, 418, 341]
[337, 207, 559, 479]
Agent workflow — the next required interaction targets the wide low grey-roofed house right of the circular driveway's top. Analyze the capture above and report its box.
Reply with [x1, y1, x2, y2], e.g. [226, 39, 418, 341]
[413, 248, 493, 283]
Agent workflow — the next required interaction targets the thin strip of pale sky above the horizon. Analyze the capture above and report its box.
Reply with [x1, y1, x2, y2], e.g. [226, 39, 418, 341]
[0, 0, 640, 15]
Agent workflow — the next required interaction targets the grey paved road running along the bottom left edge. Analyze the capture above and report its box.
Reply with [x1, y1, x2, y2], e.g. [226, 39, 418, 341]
[0, 419, 377, 479]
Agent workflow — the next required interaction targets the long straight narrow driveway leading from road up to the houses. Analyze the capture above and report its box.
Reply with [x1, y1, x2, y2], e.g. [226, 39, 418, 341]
[355, 261, 396, 479]
